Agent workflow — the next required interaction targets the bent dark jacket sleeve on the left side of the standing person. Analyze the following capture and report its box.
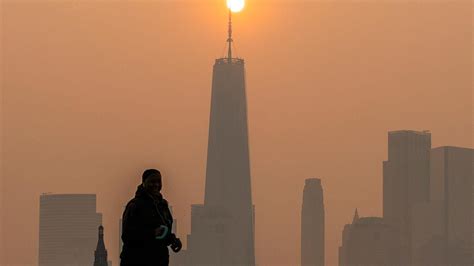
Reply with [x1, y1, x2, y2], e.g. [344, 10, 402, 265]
[122, 200, 155, 246]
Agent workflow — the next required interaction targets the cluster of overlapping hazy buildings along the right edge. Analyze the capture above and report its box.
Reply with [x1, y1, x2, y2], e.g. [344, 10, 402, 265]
[339, 130, 474, 266]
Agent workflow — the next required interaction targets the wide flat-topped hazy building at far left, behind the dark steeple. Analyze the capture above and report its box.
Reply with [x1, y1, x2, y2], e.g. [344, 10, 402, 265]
[39, 194, 102, 266]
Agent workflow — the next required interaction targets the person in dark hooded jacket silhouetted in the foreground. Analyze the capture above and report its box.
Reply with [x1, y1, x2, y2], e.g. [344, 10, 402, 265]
[120, 169, 182, 266]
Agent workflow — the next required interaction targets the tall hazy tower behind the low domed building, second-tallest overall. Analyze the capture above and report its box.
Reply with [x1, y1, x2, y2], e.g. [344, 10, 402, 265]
[383, 130, 431, 265]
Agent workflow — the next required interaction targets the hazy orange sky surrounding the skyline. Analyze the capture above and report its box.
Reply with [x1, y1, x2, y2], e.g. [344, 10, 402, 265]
[0, 0, 473, 266]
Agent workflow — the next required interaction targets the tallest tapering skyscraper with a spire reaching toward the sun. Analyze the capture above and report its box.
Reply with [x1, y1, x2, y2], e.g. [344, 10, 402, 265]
[181, 9, 255, 266]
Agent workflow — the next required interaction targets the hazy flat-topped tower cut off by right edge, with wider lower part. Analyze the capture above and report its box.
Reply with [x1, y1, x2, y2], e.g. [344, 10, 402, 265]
[413, 147, 474, 266]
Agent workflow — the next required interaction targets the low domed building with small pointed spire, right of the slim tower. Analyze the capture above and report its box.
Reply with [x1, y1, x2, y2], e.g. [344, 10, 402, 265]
[339, 209, 403, 266]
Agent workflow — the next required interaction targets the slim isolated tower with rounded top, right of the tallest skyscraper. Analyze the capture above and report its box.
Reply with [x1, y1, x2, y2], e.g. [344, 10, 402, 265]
[301, 178, 324, 266]
